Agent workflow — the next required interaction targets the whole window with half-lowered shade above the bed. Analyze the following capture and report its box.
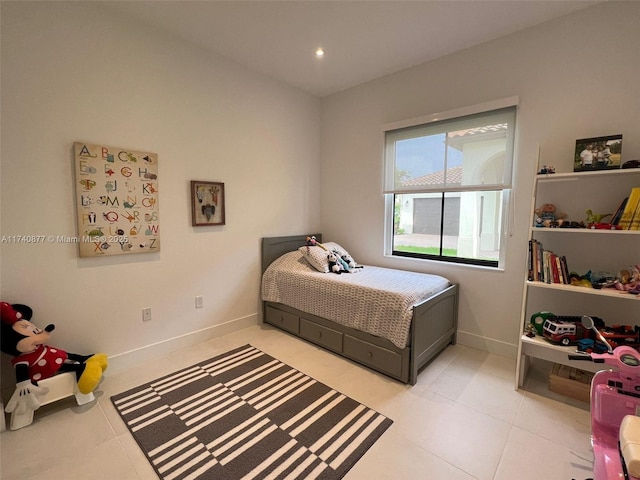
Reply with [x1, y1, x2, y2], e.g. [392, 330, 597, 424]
[384, 99, 517, 267]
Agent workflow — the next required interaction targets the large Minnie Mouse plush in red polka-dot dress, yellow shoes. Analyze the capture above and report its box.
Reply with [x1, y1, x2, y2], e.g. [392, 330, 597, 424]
[0, 302, 108, 413]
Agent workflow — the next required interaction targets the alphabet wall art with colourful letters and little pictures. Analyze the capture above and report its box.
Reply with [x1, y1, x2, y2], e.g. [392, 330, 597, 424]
[74, 142, 160, 257]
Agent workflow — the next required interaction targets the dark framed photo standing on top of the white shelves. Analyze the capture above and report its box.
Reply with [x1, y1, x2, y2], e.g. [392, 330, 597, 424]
[573, 135, 622, 172]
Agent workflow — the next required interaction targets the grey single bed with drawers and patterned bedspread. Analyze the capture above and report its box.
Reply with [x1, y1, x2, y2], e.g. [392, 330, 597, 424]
[261, 234, 458, 385]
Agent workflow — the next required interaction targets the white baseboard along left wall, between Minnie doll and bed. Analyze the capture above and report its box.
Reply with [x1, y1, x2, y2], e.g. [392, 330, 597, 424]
[108, 313, 259, 374]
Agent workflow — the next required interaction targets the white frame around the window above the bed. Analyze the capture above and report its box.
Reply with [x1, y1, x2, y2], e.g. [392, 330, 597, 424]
[382, 97, 519, 270]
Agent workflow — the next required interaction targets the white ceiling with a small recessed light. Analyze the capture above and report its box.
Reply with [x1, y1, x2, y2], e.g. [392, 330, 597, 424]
[102, 0, 600, 97]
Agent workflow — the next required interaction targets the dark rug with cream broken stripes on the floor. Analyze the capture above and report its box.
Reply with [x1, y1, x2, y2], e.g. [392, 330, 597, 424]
[111, 345, 392, 480]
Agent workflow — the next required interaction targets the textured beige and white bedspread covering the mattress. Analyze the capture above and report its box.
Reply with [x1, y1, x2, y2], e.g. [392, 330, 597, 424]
[262, 251, 451, 348]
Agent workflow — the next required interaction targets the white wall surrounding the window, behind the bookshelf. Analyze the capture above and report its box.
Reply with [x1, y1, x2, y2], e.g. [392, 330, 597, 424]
[321, 2, 640, 356]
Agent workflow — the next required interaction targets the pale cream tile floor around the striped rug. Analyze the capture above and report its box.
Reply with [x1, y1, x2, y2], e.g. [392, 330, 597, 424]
[0, 325, 593, 480]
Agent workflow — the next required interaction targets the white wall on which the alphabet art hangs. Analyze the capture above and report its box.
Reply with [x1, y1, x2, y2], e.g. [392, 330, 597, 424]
[0, 2, 320, 378]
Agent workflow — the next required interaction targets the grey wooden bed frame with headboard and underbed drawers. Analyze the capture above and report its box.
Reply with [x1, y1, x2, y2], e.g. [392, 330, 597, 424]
[262, 233, 458, 385]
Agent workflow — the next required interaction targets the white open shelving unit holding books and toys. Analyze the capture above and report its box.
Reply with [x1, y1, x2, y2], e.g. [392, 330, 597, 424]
[516, 169, 640, 388]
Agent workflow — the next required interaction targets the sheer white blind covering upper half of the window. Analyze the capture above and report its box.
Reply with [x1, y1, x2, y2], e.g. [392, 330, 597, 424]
[384, 103, 516, 194]
